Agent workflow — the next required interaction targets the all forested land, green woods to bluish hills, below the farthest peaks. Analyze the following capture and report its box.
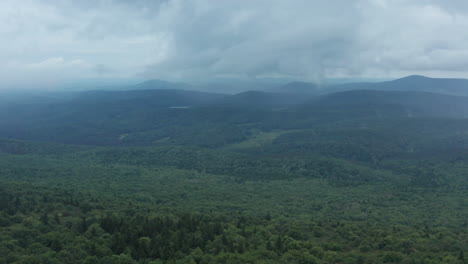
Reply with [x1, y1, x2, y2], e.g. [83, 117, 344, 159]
[0, 84, 468, 264]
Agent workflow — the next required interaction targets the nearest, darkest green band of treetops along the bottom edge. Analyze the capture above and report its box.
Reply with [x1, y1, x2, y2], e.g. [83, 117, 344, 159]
[0, 182, 466, 263]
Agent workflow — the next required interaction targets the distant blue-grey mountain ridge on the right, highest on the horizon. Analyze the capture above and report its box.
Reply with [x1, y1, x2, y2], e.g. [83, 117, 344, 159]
[328, 75, 468, 96]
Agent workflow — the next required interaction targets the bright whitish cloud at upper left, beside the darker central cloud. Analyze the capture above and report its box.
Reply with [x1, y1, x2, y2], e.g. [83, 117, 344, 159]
[0, 0, 168, 88]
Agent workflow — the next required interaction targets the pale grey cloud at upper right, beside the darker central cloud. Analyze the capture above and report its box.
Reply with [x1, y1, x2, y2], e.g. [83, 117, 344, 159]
[353, 0, 468, 77]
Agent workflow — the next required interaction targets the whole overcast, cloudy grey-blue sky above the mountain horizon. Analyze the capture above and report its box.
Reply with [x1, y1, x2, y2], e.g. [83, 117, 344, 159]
[0, 0, 468, 87]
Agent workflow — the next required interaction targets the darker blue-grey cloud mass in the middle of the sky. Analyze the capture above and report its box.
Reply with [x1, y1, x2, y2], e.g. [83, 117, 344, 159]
[148, 0, 359, 81]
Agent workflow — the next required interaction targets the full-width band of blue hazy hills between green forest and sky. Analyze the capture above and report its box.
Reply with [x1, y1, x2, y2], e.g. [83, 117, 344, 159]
[0, 76, 468, 145]
